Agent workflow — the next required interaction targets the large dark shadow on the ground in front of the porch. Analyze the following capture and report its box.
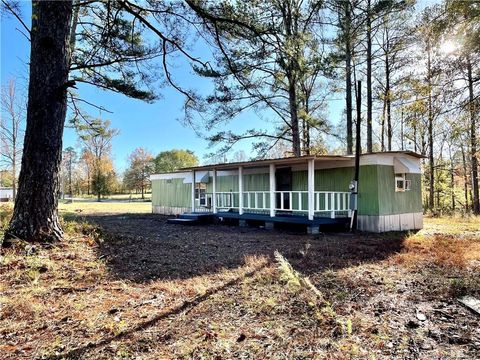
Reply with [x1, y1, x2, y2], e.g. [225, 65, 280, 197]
[86, 214, 406, 282]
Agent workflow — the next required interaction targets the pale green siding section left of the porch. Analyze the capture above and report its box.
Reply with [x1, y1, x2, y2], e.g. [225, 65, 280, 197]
[152, 178, 192, 207]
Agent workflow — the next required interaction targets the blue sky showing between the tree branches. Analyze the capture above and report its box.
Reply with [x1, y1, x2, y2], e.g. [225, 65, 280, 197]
[0, 0, 433, 171]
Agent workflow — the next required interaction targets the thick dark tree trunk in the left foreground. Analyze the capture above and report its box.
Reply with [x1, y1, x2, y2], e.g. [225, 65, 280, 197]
[5, 1, 72, 242]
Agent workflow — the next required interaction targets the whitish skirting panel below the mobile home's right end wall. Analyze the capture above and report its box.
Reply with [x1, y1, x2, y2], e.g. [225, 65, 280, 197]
[358, 212, 423, 232]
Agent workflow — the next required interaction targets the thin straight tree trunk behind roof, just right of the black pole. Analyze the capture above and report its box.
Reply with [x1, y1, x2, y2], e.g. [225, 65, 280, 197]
[344, 1, 353, 154]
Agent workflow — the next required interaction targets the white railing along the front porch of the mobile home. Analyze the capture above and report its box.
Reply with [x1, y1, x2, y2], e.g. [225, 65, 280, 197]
[205, 191, 350, 218]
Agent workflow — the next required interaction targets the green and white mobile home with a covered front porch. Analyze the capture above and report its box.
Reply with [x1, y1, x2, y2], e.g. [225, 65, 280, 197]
[151, 151, 423, 232]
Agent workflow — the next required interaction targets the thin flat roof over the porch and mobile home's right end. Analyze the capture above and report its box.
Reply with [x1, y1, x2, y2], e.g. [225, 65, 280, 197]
[180, 151, 424, 171]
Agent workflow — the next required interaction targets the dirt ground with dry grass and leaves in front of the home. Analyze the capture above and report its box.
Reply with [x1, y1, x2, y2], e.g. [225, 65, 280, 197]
[0, 214, 480, 359]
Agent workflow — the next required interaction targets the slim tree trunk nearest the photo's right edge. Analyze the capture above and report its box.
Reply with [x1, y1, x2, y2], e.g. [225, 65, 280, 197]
[467, 56, 480, 215]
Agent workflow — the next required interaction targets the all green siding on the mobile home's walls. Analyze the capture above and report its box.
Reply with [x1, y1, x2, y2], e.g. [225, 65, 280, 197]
[152, 165, 422, 215]
